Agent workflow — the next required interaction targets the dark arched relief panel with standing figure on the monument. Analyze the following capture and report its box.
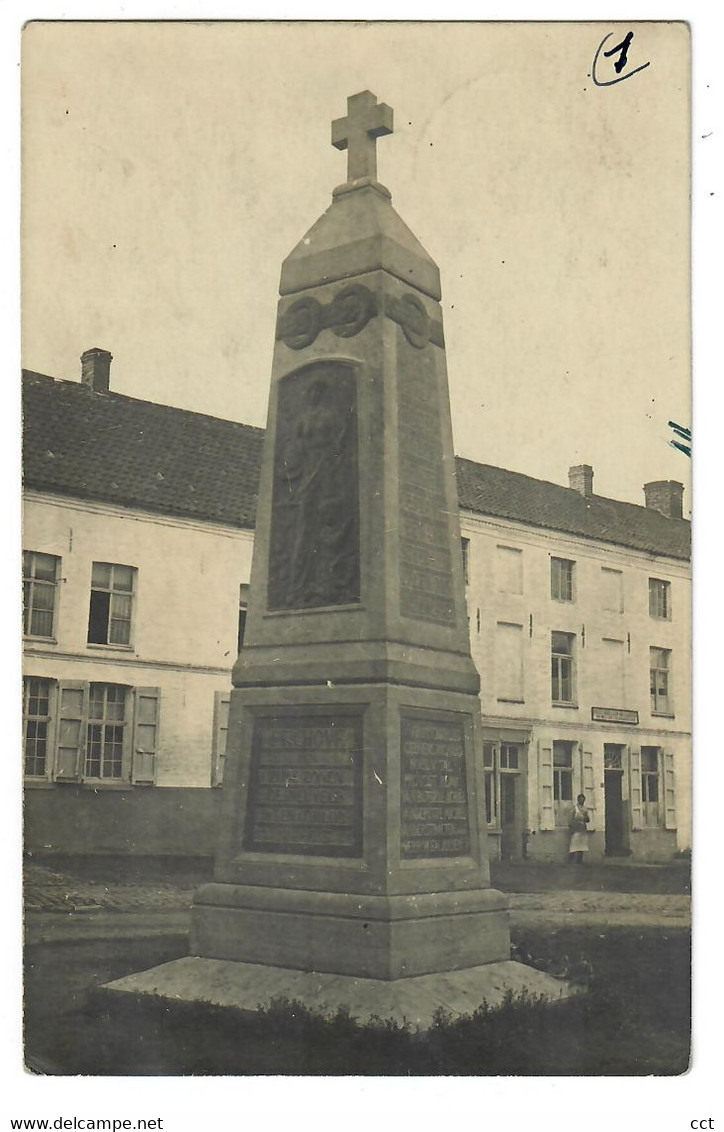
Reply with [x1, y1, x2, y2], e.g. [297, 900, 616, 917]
[268, 362, 360, 609]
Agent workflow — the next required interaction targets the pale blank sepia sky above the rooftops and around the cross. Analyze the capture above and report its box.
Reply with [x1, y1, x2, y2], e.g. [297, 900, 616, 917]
[23, 23, 691, 514]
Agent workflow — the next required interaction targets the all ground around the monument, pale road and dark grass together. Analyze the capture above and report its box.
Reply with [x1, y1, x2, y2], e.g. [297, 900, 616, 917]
[25, 858, 690, 1075]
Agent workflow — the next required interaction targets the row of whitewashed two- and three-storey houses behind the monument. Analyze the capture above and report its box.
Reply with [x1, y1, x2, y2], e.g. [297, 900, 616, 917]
[24, 349, 691, 859]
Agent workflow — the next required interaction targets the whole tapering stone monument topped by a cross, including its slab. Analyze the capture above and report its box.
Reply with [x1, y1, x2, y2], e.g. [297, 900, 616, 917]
[106, 91, 570, 1018]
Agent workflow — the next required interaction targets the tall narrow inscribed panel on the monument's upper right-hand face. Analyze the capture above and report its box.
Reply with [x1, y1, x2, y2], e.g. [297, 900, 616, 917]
[397, 367, 455, 625]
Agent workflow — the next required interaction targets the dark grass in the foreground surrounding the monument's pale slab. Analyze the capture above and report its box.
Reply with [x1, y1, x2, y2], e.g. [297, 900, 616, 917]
[26, 927, 690, 1075]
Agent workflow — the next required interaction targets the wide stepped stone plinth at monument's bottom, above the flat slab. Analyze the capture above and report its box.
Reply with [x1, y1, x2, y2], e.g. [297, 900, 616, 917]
[191, 883, 510, 979]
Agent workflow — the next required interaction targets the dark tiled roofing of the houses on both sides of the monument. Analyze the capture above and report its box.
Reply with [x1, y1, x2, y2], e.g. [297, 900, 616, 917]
[23, 371, 690, 559]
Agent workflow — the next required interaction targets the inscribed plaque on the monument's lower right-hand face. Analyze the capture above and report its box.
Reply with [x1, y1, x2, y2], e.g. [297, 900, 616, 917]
[400, 715, 471, 858]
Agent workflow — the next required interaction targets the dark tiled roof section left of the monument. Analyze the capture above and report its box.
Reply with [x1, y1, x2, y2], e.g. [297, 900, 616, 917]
[23, 371, 264, 528]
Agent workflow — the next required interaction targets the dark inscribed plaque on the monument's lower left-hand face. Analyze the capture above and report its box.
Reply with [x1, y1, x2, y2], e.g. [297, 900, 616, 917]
[244, 713, 362, 857]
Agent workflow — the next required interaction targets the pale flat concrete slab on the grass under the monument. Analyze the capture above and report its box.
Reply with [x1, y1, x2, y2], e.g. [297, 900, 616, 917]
[104, 955, 580, 1030]
